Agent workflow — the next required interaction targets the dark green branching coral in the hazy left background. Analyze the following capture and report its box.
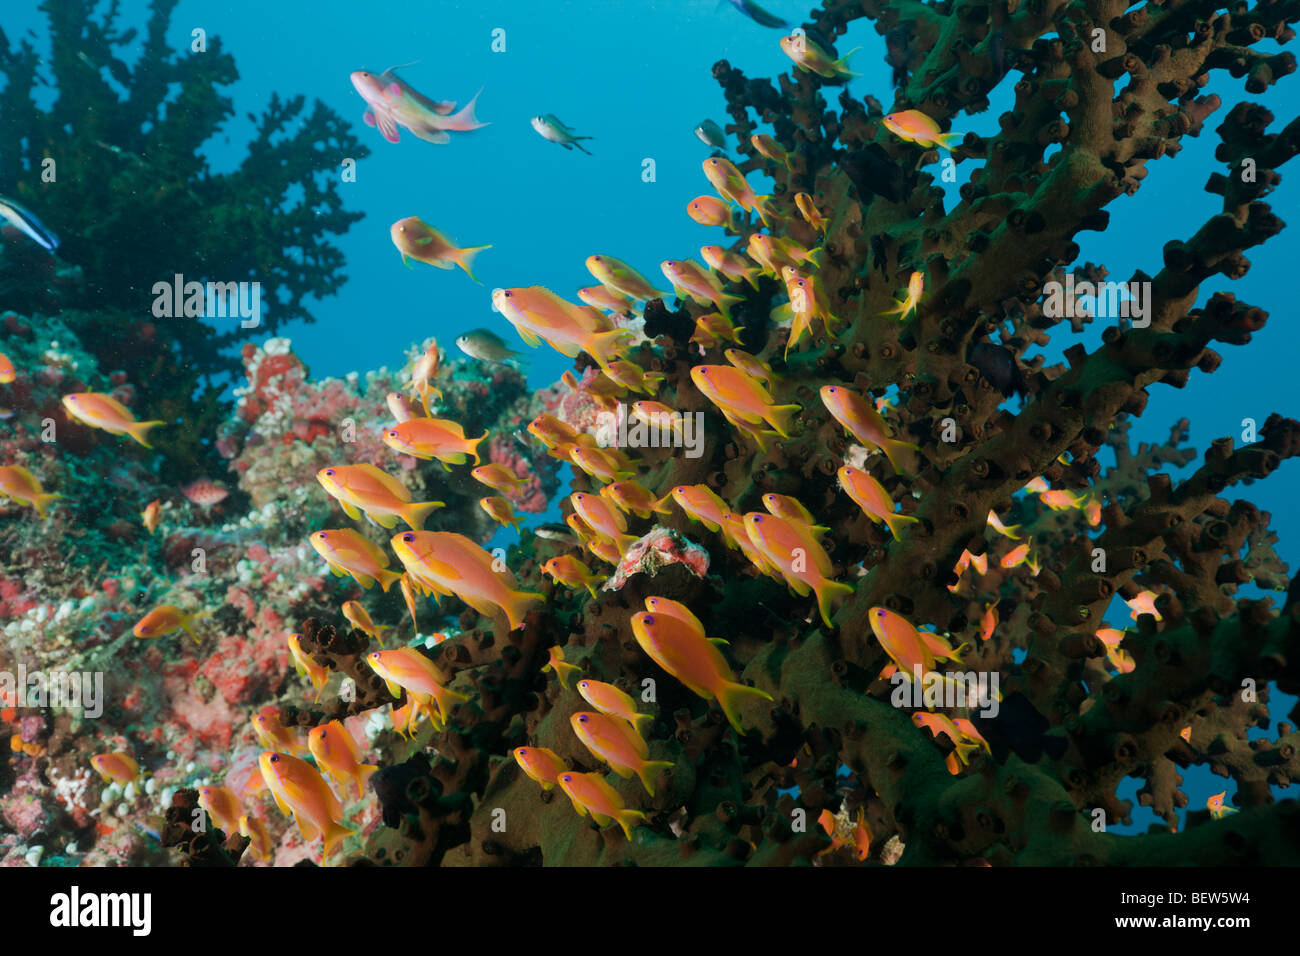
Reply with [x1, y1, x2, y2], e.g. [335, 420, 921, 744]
[0, 0, 369, 479]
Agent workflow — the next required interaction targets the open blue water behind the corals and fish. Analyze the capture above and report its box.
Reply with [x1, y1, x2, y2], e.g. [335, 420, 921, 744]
[0, 0, 1300, 830]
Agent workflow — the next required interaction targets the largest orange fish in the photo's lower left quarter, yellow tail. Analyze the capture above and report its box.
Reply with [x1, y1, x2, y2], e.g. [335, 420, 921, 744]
[391, 531, 545, 631]
